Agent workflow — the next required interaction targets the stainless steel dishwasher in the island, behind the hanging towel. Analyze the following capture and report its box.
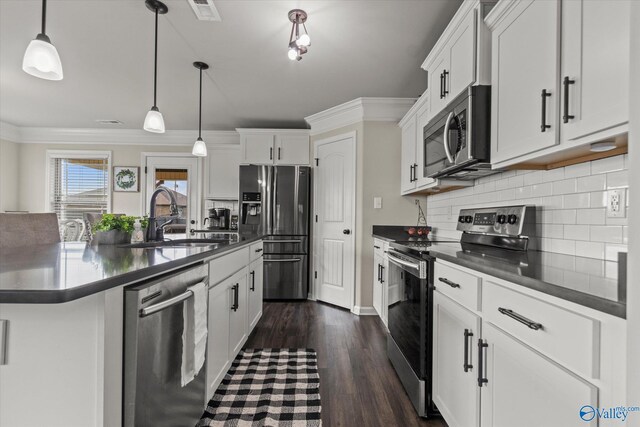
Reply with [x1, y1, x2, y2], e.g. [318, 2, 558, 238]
[123, 264, 208, 427]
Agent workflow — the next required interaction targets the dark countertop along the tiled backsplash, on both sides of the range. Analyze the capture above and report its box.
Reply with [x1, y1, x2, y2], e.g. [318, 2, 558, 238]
[373, 227, 627, 318]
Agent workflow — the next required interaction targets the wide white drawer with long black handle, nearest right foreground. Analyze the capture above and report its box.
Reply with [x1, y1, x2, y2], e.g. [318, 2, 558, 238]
[482, 282, 600, 378]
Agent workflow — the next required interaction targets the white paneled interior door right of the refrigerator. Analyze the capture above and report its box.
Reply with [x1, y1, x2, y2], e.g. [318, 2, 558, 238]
[314, 133, 356, 309]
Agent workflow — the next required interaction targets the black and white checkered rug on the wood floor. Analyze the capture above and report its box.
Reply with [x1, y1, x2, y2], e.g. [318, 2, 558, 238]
[198, 348, 322, 427]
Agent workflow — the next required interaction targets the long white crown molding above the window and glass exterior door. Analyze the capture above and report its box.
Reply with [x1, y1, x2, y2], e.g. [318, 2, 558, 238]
[0, 122, 240, 146]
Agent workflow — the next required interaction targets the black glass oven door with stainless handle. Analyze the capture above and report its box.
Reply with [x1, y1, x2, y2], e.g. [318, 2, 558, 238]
[388, 250, 429, 379]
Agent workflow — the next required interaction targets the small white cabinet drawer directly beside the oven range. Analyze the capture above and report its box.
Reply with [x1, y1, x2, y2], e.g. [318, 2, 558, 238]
[433, 261, 481, 310]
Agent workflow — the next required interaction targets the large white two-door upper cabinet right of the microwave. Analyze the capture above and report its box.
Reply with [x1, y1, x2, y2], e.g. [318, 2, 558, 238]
[486, 0, 630, 168]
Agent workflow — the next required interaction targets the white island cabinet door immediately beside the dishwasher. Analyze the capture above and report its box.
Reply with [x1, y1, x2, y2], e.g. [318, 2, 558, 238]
[206, 281, 231, 401]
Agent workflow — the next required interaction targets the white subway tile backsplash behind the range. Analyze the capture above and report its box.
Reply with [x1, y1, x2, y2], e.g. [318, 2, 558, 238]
[427, 155, 633, 261]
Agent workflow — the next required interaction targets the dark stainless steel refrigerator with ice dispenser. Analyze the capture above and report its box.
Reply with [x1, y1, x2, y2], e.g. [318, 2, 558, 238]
[238, 165, 311, 299]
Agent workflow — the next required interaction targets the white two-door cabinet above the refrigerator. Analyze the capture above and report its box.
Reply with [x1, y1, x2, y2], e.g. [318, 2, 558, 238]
[237, 129, 309, 165]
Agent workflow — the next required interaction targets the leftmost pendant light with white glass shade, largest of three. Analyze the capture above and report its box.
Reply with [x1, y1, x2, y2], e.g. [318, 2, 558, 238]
[22, 0, 63, 80]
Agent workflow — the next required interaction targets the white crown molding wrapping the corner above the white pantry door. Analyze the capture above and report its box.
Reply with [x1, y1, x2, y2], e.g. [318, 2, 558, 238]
[305, 98, 416, 135]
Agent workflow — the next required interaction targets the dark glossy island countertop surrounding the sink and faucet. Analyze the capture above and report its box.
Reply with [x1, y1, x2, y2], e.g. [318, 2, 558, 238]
[0, 235, 263, 304]
